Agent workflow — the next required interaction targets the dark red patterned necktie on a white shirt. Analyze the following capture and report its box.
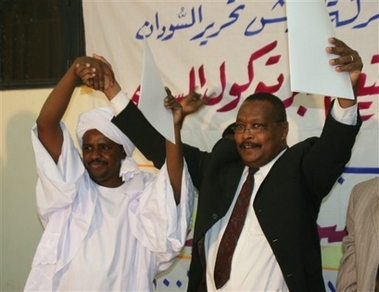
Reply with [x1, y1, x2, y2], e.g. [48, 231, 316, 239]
[214, 168, 258, 289]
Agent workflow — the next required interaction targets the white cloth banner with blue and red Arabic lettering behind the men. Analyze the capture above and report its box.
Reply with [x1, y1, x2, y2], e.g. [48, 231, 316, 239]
[83, 0, 379, 291]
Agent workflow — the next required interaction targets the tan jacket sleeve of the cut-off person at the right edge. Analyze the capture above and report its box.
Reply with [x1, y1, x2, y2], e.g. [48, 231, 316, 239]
[337, 189, 357, 291]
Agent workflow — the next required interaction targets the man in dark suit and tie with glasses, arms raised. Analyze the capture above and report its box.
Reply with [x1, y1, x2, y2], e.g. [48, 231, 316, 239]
[85, 39, 363, 292]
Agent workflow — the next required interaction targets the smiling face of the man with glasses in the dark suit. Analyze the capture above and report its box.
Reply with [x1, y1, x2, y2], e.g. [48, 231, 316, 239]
[234, 100, 288, 168]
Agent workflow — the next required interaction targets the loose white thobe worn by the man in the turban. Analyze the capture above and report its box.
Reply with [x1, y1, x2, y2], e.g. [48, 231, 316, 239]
[25, 124, 193, 291]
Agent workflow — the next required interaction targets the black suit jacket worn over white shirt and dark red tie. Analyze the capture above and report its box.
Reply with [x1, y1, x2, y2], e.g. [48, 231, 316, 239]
[113, 102, 361, 292]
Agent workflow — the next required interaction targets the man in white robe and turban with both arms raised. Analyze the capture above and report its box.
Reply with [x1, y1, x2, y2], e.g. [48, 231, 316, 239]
[25, 57, 193, 291]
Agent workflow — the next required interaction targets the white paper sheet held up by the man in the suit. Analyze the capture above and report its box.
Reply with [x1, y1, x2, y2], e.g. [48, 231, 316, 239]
[286, 0, 354, 99]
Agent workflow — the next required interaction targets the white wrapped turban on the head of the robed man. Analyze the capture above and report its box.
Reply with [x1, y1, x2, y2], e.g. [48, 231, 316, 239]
[76, 107, 139, 181]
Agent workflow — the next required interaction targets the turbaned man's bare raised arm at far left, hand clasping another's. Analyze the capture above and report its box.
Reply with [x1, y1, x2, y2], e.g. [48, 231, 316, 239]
[36, 57, 113, 162]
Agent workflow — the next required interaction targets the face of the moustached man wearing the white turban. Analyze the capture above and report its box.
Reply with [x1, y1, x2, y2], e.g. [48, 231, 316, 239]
[82, 129, 126, 188]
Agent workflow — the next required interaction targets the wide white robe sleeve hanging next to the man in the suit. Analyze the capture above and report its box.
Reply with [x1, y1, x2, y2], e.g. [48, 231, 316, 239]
[129, 164, 194, 270]
